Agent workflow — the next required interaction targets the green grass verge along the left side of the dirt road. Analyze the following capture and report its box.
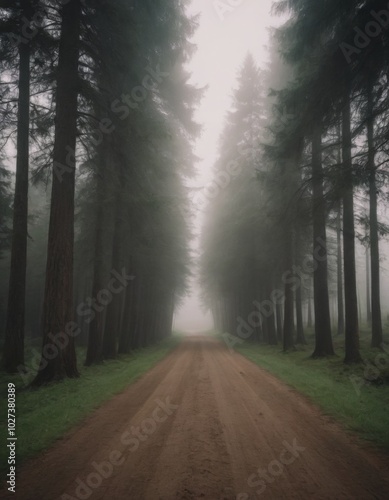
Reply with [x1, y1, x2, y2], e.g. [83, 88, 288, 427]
[0, 335, 181, 475]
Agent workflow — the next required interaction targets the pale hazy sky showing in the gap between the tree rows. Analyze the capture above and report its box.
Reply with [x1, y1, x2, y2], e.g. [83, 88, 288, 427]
[174, 0, 279, 331]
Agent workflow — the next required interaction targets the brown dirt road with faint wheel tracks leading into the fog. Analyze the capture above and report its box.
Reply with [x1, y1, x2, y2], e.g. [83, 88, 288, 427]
[2, 336, 389, 500]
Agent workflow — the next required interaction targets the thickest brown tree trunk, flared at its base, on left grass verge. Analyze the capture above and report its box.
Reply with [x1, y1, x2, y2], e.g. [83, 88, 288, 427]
[32, 0, 81, 385]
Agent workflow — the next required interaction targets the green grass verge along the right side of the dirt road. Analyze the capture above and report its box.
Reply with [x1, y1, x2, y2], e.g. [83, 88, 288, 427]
[233, 337, 389, 452]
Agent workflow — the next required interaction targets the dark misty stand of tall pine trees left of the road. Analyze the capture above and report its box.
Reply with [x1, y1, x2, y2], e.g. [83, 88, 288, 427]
[0, 0, 201, 385]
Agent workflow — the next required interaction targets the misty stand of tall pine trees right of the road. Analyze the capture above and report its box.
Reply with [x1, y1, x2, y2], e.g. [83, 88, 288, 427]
[201, 0, 389, 363]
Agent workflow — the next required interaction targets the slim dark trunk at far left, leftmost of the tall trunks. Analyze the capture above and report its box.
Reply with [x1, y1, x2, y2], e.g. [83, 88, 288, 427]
[3, 0, 32, 373]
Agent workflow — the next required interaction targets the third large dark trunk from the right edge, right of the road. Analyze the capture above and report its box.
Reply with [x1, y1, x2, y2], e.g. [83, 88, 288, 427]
[312, 124, 334, 358]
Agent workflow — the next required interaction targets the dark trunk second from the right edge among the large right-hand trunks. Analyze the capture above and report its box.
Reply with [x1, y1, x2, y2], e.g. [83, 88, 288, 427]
[342, 91, 361, 363]
